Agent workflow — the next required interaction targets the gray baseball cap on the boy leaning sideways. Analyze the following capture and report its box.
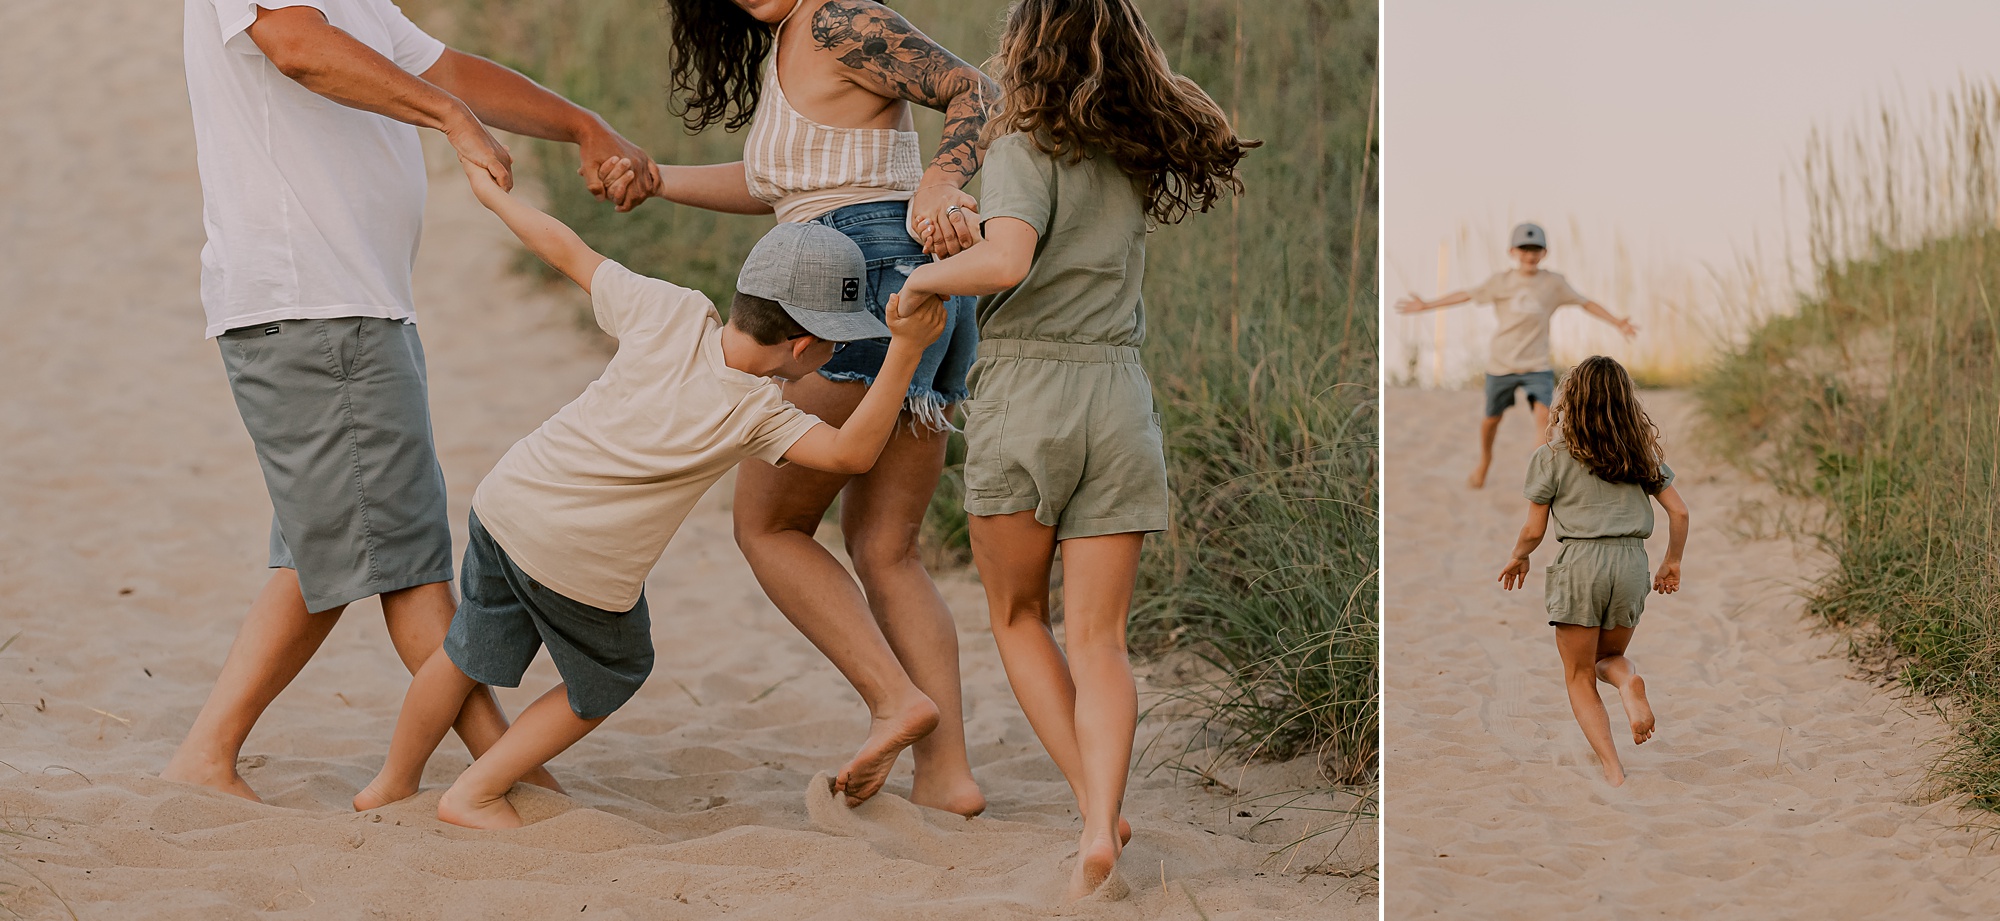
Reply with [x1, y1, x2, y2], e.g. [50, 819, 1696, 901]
[736, 222, 888, 342]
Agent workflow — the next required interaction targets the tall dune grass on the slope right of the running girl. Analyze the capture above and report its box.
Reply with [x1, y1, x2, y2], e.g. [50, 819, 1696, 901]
[1700, 84, 2000, 811]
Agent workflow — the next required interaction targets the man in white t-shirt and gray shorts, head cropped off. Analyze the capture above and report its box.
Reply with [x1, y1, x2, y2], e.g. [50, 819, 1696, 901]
[162, 0, 650, 799]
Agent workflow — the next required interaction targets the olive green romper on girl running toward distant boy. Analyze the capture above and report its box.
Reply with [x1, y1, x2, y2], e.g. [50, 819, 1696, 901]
[1522, 438, 1674, 629]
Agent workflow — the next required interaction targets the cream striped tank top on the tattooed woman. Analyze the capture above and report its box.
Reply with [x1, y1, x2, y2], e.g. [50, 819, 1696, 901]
[744, 5, 924, 222]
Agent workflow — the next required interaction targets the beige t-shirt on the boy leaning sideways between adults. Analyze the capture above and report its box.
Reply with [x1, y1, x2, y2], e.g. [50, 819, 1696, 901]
[472, 260, 820, 611]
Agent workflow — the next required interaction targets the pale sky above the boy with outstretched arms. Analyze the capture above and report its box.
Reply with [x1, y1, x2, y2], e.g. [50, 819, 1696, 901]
[1382, 0, 2000, 380]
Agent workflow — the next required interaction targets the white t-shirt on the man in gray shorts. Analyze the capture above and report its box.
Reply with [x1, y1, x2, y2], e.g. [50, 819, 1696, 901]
[182, 0, 444, 336]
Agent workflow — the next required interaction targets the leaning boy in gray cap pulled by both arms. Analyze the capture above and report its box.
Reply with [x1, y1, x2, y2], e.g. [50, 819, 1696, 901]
[354, 155, 944, 829]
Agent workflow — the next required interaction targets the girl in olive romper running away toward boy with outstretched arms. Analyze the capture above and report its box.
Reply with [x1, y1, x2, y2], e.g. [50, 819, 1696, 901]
[1500, 354, 1688, 787]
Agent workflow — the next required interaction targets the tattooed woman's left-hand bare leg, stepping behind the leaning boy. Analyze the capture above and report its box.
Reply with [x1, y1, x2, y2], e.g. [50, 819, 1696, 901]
[734, 374, 938, 805]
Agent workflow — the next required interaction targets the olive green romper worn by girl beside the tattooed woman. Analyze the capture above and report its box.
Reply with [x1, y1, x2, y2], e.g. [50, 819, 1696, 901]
[964, 134, 1166, 541]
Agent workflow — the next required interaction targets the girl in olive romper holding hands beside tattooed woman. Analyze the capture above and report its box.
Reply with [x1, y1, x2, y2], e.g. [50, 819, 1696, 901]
[900, 0, 1256, 897]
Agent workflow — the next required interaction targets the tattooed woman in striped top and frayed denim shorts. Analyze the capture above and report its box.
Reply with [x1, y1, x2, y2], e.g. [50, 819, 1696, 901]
[614, 0, 994, 815]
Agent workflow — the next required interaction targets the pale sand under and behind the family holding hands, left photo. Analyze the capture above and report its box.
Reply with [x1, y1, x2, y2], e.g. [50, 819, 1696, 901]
[0, 0, 1376, 919]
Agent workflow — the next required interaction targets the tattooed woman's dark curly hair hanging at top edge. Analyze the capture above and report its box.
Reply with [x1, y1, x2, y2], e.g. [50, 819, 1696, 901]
[666, 0, 776, 132]
